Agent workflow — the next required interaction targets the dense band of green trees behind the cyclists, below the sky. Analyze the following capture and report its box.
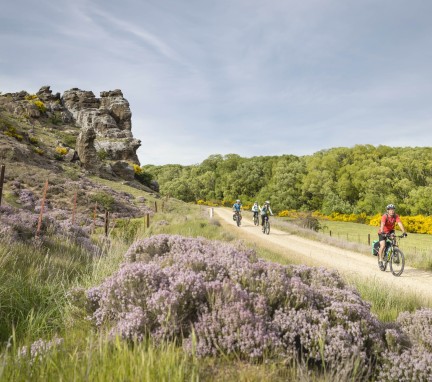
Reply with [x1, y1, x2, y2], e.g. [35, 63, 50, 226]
[142, 145, 432, 215]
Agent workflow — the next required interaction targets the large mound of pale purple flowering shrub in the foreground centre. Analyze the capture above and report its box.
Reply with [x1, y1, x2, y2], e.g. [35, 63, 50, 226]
[87, 235, 385, 372]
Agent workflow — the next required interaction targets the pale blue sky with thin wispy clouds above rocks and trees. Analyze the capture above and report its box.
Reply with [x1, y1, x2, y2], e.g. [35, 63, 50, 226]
[0, 0, 432, 165]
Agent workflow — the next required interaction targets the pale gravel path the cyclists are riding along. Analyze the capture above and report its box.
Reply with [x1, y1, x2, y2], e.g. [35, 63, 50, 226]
[214, 208, 432, 302]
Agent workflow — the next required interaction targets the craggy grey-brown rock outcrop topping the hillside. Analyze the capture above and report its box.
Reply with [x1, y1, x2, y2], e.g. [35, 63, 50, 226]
[0, 86, 141, 181]
